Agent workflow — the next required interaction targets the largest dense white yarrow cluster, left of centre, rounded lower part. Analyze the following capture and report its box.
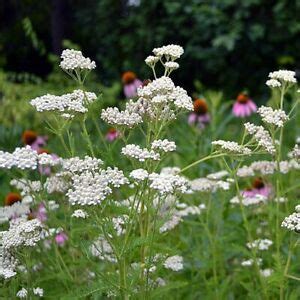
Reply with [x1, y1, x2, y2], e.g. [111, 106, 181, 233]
[67, 168, 129, 205]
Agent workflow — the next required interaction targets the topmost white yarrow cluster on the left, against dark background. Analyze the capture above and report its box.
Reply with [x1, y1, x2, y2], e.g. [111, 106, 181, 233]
[60, 49, 96, 71]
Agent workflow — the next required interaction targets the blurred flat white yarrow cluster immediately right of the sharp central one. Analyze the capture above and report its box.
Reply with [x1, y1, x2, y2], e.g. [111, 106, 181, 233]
[190, 175, 230, 193]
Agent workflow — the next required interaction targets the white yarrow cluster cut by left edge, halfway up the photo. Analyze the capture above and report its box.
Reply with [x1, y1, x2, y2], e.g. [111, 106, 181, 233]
[0, 146, 38, 170]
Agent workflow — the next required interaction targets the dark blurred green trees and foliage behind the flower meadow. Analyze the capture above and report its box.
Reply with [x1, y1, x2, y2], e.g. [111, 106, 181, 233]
[0, 0, 300, 98]
